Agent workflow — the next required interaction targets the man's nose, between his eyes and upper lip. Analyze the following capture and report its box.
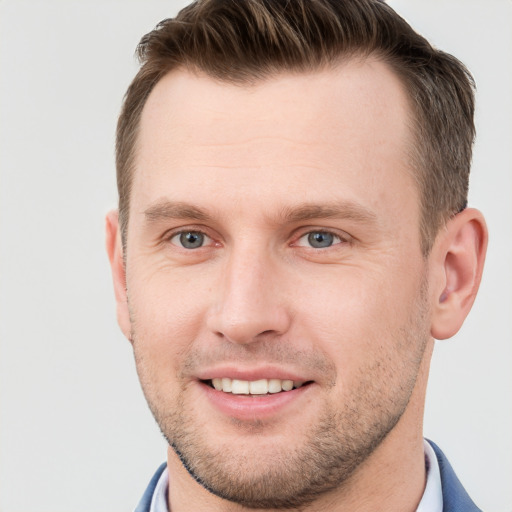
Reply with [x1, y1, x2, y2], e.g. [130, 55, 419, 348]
[208, 244, 291, 344]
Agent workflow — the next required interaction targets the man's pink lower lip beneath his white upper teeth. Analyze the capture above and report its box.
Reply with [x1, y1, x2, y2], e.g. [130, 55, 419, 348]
[200, 382, 314, 421]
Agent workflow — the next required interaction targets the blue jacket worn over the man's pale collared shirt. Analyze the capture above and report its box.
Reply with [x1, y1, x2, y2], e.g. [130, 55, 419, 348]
[134, 441, 482, 512]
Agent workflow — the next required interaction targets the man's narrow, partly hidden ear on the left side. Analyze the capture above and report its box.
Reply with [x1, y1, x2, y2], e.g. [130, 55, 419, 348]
[106, 210, 132, 341]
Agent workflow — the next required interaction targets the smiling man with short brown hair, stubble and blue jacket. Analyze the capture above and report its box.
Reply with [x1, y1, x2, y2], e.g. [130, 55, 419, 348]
[107, 0, 487, 512]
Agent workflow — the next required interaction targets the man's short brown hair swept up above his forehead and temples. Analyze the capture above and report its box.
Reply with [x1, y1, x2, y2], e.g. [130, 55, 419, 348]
[116, 0, 475, 255]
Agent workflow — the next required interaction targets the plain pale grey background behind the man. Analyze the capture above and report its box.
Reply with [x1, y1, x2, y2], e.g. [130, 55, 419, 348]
[0, 0, 512, 512]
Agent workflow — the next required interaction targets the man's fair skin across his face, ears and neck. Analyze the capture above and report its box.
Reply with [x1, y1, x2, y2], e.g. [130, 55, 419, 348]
[107, 59, 487, 512]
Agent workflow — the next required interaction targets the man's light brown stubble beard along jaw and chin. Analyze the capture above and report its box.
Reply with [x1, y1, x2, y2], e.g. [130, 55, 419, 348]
[132, 287, 429, 509]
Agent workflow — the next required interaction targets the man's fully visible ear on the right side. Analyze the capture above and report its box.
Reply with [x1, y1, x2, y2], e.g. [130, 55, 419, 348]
[431, 208, 488, 340]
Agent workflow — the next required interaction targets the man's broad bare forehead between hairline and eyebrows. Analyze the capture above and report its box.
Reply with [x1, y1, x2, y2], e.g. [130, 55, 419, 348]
[131, 59, 418, 230]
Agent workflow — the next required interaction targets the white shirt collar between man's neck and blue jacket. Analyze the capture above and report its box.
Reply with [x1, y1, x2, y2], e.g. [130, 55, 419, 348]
[149, 440, 443, 512]
